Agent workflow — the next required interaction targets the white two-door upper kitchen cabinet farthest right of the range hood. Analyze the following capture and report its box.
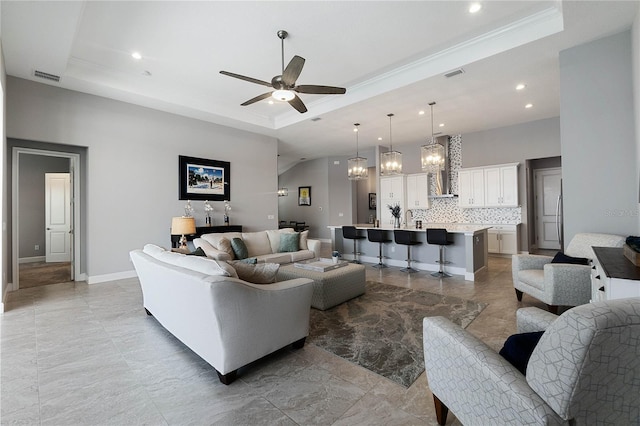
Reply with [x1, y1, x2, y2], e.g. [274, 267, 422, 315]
[484, 163, 518, 207]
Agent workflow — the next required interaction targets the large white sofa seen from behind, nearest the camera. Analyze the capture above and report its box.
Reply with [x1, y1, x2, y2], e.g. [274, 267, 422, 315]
[130, 244, 313, 384]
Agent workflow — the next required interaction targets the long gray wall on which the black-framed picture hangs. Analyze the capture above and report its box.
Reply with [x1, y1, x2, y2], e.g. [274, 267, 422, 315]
[5, 77, 280, 277]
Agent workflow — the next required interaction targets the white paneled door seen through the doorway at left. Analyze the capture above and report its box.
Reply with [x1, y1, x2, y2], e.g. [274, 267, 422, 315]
[45, 173, 71, 262]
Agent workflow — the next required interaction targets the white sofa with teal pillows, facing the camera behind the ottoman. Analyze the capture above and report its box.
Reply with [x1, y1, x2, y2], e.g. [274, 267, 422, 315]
[193, 228, 320, 264]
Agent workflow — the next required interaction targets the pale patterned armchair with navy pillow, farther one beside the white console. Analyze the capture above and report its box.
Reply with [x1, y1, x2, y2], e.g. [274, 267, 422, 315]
[511, 233, 625, 313]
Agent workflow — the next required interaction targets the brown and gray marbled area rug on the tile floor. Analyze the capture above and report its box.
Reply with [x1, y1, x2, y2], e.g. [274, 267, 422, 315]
[308, 281, 487, 388]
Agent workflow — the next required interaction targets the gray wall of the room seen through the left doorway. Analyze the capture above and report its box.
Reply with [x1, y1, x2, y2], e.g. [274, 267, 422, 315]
[18, 154, 69, 259]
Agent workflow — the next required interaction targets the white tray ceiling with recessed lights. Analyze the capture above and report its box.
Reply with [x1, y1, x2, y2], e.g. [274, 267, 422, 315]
[0, 0, 639, 171]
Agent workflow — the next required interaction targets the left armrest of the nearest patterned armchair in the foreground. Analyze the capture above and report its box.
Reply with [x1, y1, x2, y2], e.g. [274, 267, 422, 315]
[423, 317, 564, 424]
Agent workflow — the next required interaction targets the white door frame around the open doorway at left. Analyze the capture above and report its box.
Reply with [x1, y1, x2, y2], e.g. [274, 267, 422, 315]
[11, 147, 82, 291]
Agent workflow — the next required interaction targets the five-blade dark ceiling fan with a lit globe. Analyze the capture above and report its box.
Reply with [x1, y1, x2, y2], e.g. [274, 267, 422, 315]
[220, 30, 347, 113]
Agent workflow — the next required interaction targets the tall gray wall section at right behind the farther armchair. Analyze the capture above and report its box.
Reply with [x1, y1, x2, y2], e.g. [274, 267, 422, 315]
[560, 31, 638, 242]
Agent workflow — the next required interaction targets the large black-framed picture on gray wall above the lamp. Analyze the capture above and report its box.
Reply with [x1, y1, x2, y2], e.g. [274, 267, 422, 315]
[178, 155, 231, 201]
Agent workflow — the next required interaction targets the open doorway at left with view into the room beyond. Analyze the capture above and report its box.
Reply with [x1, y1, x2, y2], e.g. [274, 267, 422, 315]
[11, 147, 80, 290]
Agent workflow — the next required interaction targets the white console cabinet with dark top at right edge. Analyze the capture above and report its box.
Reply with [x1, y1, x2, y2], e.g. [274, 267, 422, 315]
[591, 247, 640, 302]
